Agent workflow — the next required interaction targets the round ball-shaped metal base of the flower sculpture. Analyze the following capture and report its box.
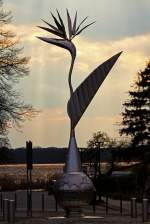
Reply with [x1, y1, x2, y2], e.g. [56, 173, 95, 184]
[54, 172, 95, 213]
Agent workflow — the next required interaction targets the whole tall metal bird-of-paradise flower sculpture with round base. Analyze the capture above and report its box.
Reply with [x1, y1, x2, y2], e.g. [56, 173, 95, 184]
[38, 10, 121, 215]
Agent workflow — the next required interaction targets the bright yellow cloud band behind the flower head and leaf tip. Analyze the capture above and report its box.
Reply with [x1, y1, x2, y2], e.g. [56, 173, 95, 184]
[8, 25, 150, 71]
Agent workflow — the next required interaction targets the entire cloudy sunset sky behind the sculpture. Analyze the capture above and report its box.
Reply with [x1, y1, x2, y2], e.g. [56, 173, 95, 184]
[4, 0, 150, 147]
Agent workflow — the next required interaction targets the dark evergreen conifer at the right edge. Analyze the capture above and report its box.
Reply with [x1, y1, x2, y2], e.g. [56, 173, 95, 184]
[120, 61, 150, 147]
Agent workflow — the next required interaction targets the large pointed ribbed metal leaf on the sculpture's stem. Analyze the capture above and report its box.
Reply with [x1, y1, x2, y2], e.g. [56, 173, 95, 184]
[67, 52, 122, 129]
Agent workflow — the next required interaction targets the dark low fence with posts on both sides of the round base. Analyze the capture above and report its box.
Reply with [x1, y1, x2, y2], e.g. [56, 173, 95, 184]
[0, 191, 149, 222]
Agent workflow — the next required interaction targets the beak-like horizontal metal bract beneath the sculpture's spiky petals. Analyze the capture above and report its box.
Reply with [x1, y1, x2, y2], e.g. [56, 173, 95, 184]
[37, 37, 76, 59]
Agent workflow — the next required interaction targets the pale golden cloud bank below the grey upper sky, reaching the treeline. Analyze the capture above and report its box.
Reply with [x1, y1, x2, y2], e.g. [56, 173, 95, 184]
[6, 21, 150, 146]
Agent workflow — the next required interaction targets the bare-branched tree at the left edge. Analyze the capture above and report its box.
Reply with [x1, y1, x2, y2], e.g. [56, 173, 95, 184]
[0, 0, 34, 146]
